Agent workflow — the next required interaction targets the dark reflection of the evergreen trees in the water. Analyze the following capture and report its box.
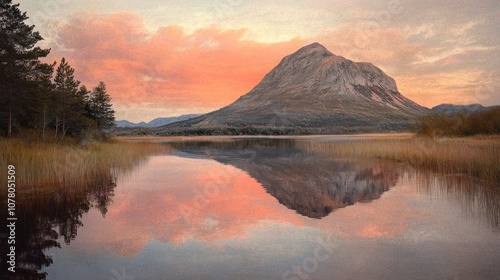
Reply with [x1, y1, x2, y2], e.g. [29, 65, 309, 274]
[0, 178, 116, 279]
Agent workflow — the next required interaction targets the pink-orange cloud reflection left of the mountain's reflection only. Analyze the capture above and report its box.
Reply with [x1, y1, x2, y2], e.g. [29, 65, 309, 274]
[77, 157, 303, 255]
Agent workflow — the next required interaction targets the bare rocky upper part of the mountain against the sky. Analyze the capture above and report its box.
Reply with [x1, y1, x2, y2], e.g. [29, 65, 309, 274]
[256, 43, 398, 95]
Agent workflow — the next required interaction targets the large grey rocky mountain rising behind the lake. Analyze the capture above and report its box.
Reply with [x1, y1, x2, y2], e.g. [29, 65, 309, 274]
[157, 43, 429, 135]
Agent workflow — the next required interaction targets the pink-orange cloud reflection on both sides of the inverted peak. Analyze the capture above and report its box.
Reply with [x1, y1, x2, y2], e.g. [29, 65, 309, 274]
[75, 154, 418, 255]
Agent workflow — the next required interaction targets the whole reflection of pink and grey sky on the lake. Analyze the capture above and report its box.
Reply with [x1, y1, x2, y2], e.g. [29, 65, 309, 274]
[49, 149, 500, 279]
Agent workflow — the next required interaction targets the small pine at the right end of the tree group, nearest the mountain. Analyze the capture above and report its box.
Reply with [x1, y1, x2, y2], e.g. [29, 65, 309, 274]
[88, 82, 115, 132]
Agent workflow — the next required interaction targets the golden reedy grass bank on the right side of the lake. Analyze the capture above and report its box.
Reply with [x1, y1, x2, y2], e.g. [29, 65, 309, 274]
[298, 136, 500, 182]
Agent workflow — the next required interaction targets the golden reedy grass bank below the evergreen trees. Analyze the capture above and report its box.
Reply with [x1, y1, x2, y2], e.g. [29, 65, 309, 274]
[0, 139, 170, 191]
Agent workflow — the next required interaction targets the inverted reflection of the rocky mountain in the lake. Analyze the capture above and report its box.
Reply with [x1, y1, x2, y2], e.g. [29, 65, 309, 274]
[173, 140, 398, 218]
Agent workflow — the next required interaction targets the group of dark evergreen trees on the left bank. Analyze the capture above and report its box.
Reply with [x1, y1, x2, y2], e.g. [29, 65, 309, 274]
[0, 0, 114, 139]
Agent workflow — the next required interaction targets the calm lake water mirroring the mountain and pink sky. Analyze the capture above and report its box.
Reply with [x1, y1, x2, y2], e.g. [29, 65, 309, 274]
[3, 139, 500, 280]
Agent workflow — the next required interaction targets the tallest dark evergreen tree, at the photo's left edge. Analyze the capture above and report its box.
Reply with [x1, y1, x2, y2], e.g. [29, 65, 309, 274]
[0, 0, 50, 136]
